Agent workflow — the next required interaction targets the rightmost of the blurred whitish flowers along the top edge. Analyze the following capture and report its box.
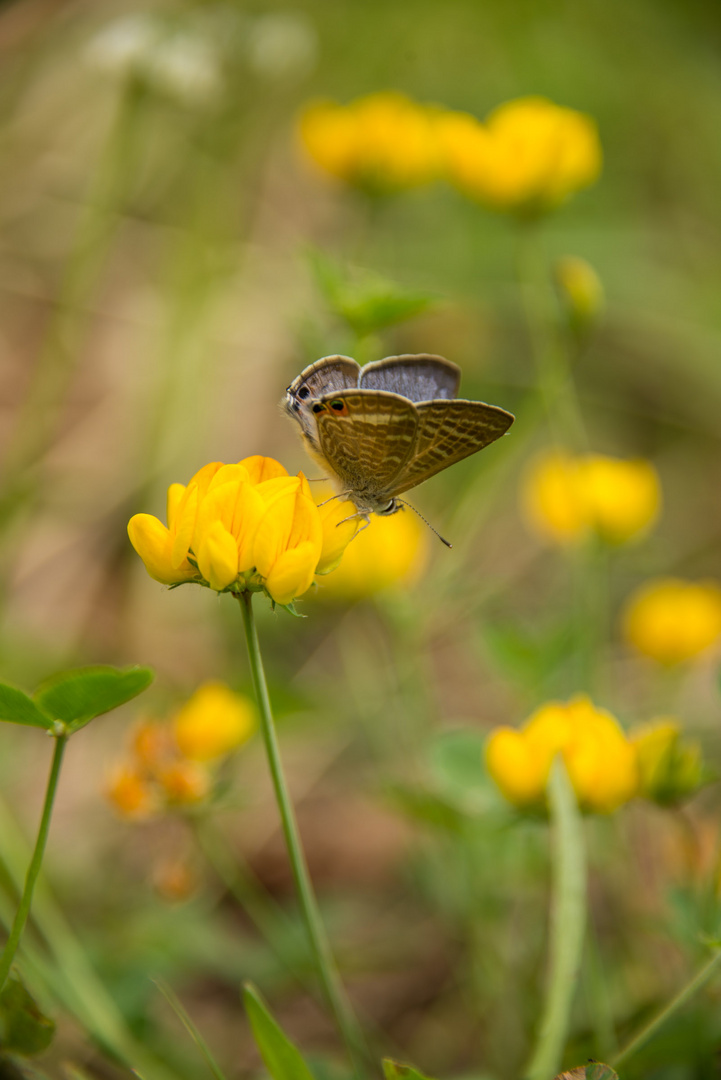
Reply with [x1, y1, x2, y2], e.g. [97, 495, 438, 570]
[247, 12, 318, 79]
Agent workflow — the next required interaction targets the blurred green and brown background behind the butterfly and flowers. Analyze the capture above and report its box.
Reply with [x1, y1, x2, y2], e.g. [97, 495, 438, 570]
[0, 0, 721, 1080]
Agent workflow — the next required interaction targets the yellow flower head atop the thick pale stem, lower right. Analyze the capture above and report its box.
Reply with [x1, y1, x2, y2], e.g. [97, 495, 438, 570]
[486, 694, 638, 813]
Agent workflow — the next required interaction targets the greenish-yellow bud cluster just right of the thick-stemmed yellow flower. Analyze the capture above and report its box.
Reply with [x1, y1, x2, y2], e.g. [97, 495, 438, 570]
[630, 716, 704, 806]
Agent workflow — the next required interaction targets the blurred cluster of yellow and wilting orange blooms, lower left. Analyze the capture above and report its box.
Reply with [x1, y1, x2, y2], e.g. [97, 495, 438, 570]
[107, 683, 257, 820]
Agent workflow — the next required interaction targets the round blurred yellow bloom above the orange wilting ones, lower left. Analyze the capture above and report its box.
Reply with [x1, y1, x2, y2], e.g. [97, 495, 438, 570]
[173, 683, 257, 761]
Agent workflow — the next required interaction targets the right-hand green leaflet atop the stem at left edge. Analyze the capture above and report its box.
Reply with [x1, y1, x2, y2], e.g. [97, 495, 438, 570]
[35, 667, 153, 733]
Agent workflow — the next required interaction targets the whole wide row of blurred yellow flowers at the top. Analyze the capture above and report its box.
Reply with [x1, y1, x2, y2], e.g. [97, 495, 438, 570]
[299, 91, 601, 216]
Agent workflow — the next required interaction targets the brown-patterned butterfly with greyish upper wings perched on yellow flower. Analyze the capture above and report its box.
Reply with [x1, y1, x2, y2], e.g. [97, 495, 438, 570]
[283, 353, 514, 531]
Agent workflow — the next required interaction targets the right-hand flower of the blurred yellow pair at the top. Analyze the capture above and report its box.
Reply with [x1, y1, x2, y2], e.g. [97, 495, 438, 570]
[437, 97, 602, 215]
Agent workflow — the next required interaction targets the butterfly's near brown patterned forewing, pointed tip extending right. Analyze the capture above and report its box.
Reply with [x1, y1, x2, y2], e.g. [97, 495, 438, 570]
[390, 401, 515, 496]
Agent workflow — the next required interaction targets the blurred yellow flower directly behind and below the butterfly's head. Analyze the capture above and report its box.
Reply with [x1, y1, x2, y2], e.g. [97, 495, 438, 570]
[318, 503, 428, 600]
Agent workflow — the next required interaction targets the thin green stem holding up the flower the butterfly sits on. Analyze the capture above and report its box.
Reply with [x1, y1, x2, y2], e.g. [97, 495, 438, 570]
[239, 592, 367, 1076]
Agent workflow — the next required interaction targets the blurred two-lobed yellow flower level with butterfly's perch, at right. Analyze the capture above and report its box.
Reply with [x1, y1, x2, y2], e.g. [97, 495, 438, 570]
[521, 453, 662, 543]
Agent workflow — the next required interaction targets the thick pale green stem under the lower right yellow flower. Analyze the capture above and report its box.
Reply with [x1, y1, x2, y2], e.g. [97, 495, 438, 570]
[525, 757, 586, 1080]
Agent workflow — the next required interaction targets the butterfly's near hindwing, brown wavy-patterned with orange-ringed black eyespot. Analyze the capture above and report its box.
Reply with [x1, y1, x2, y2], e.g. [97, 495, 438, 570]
[311, 389, 419, 501]
